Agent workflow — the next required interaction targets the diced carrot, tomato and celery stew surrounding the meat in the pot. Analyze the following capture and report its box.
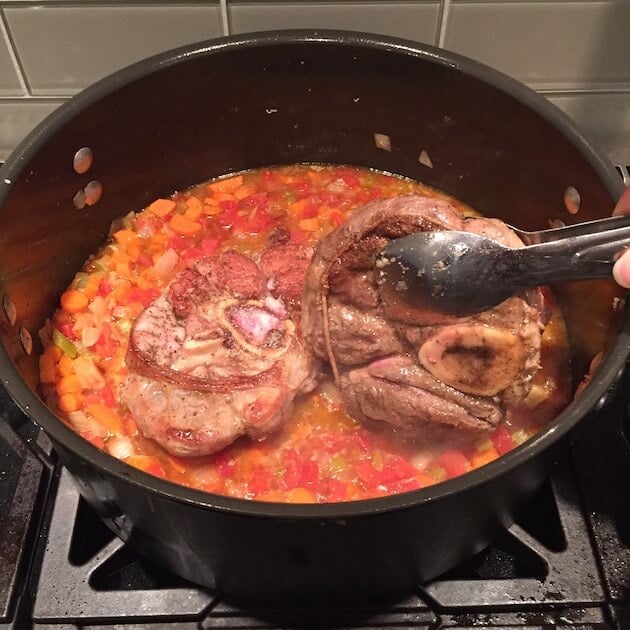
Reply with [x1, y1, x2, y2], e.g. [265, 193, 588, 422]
[39, 165, 569, 503]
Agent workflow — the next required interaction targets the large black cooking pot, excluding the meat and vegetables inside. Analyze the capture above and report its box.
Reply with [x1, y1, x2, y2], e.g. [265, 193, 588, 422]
[0, 31, 630, 599]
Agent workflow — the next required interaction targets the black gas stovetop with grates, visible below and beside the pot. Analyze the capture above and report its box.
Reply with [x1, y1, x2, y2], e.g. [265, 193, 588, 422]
[0, 370, 630, 630]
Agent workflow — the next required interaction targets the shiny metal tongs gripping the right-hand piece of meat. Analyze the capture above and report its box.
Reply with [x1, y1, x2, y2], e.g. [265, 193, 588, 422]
[375, 216, 630, 316]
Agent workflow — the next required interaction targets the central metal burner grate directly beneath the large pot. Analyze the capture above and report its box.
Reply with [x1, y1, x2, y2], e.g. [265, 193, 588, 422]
[25, 462, 606, 630]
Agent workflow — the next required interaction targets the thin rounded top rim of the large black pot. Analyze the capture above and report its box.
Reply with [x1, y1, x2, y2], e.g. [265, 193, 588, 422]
[0, 29, 630, 520]
